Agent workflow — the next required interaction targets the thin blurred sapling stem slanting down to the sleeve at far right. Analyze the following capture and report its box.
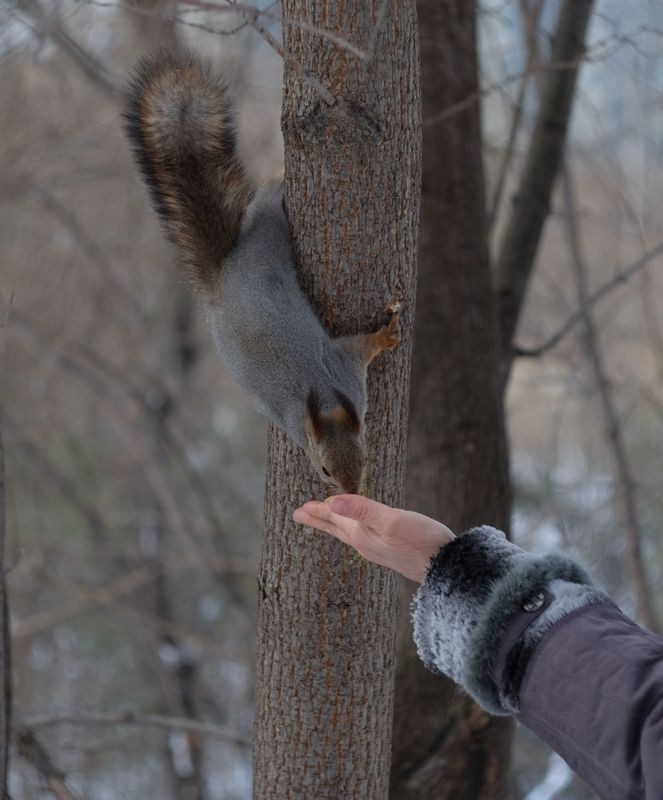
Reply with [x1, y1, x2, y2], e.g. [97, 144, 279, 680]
[562, 168, 658, 631]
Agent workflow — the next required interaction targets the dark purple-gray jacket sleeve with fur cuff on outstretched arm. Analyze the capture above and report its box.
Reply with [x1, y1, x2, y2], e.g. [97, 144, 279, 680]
[412, 526, 663, 800]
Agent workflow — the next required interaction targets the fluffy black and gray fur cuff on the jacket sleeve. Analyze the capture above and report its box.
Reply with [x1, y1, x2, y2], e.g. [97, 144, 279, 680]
[412, 525, 607, 714]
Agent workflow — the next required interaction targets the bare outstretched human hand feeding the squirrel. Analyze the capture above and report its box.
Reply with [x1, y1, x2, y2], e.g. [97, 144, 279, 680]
[293, 494, 455, 583]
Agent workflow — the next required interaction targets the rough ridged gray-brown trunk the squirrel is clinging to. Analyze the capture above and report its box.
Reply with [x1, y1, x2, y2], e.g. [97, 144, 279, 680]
[254, 0, 420, 800]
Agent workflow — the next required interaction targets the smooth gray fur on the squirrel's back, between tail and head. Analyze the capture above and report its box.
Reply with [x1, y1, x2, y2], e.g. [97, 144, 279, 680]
[209, 183, 366, 447]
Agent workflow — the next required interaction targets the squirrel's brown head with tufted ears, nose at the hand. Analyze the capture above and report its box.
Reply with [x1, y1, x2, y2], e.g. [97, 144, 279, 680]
[306, 389, 366, 494]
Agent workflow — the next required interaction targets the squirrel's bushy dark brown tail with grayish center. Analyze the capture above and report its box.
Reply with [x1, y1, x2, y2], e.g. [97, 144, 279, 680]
[124, 52, 253, 289]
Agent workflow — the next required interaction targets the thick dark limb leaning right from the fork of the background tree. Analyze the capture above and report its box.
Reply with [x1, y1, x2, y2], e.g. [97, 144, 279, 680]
[496, 0, 593, 383]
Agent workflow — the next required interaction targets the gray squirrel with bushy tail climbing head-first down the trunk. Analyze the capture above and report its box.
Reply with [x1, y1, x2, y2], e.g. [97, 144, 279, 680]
[124, 51, 401, 493]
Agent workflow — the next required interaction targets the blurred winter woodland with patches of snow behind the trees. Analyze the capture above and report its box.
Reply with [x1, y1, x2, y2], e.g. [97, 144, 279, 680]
[0, 0, 663, 800]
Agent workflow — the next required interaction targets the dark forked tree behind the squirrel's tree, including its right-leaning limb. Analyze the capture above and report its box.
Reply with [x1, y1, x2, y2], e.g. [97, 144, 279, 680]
[391, 6, 592, 800]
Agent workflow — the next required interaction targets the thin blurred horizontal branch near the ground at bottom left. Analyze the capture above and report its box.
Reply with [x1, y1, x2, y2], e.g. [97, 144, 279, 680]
[24, 711, 250, 747]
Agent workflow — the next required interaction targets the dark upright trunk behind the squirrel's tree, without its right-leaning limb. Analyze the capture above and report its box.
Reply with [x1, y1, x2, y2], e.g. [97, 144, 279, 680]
[391, 0, 512, 800]
